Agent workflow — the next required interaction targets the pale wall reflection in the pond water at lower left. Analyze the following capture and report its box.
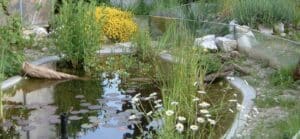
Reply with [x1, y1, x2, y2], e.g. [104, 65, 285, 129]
[4, 86, 57, 139]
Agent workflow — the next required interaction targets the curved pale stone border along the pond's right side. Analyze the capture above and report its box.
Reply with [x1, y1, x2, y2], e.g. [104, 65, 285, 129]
[222, 77, 256, 139]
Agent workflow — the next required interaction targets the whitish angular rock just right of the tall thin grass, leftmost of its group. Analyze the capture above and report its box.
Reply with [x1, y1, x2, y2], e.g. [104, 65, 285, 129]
[194, 35, 218, 51]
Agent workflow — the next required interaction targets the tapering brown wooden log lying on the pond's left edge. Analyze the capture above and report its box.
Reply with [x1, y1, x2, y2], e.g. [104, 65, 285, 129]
[22, 62, 79, 80]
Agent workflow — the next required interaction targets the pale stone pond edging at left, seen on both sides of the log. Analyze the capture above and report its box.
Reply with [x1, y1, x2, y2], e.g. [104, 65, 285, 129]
[0, 56, 61, 91]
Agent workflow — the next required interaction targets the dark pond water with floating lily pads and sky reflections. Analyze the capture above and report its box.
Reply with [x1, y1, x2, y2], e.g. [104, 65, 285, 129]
[0, 73, 236, 139]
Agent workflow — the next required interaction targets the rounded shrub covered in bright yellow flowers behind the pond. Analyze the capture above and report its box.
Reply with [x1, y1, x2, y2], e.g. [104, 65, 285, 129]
[96, 7, 137, 42]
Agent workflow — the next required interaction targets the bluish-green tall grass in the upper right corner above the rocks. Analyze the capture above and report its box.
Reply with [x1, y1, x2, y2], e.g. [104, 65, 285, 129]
[232, 0, 296, 26]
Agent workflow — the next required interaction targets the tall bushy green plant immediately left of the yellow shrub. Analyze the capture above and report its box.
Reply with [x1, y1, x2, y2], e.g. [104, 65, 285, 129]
[54, 0, 102, 68]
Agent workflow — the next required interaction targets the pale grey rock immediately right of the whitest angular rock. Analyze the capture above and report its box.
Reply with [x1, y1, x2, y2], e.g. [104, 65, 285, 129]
[216, 37, 237, 52]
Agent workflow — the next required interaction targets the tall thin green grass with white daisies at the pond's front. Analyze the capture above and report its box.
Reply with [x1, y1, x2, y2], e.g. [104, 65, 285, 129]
[151, 22, 233, 139]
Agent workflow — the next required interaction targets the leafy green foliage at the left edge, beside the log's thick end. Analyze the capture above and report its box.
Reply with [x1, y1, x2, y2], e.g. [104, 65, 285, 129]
[0, 16, 29, 80]
